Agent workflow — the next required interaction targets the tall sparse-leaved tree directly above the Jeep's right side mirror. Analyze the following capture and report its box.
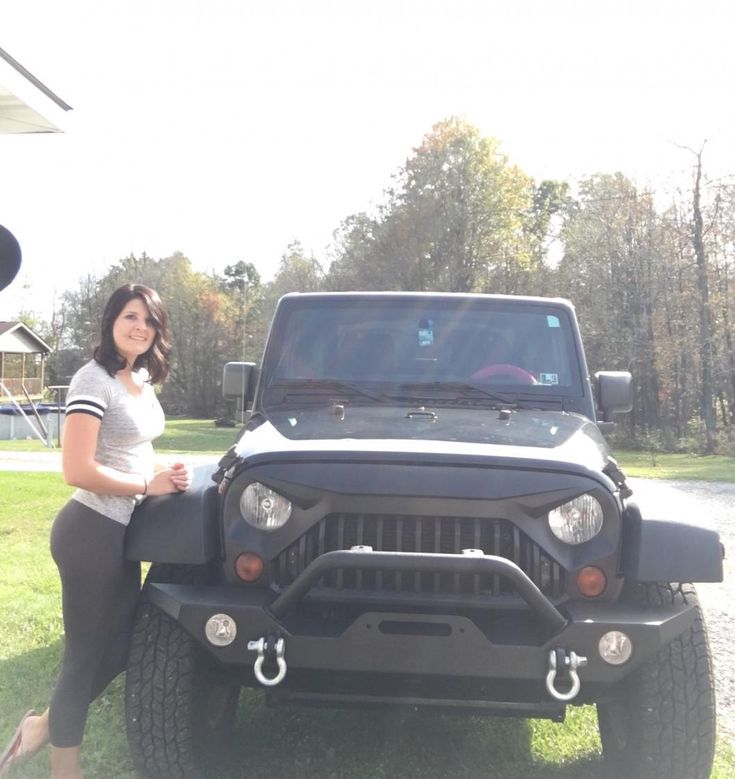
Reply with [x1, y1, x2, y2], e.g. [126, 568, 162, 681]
[555, 174, 663, 438]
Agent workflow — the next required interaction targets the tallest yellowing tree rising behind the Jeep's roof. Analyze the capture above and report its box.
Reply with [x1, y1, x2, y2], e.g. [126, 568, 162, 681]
[328, 118, 543, 292]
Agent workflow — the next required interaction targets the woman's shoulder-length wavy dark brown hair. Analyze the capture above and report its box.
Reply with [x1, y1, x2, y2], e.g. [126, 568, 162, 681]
[94, 284, 171, 384]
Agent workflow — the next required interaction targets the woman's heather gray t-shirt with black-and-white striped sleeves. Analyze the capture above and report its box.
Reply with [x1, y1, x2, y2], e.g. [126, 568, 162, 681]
[66, 360, 165, 525]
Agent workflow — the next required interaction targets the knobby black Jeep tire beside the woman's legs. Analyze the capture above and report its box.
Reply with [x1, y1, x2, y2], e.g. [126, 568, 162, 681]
[125, 565, 240, 779]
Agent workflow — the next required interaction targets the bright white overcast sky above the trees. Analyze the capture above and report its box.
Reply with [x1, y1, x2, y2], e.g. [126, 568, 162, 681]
[0, 0, 735, 319]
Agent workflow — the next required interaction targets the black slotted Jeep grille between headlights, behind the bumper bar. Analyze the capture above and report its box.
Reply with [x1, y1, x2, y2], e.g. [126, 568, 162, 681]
[273, 514, 564, 600]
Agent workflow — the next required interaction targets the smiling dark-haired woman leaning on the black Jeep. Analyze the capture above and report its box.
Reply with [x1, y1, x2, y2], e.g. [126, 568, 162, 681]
[0, 284, 190, 779]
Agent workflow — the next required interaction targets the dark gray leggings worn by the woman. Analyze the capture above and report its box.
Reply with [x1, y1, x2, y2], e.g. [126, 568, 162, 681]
[49, 500, 140, 747]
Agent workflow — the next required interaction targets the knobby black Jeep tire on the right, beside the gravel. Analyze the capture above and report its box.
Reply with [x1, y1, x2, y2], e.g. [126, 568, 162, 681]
[597, 584, 715, 779]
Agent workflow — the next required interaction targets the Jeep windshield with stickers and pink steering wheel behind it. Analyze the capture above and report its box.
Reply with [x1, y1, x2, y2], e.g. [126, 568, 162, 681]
[261, 293, 582, 408]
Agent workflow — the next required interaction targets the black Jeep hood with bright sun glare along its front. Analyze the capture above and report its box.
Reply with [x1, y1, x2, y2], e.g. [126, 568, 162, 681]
[236, 405, 609, 471]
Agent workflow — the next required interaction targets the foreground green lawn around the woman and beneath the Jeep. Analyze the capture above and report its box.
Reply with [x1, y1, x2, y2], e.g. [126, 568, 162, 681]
[0, 472, 735, 779]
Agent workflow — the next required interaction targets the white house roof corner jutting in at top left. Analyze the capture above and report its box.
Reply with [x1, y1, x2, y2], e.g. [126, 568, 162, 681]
[0, 49, 71, 133]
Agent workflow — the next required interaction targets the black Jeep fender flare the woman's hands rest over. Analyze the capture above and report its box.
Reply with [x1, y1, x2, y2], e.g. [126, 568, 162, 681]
[125, 463, 220, 565]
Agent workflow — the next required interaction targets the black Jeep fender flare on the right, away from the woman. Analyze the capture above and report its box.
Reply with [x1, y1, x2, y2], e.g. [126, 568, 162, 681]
[622, 503, 724, 582]
